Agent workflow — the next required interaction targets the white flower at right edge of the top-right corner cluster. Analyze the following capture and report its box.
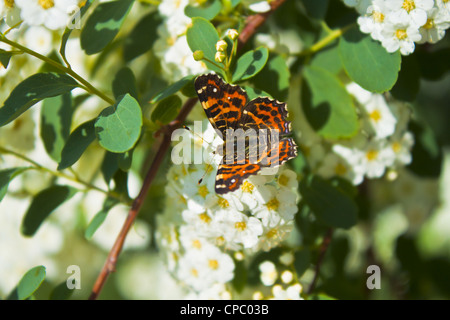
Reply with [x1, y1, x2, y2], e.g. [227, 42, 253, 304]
[418, 8, 450, 43]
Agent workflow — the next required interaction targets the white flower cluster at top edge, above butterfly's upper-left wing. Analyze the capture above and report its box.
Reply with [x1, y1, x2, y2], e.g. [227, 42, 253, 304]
[153, 0, 206, 82]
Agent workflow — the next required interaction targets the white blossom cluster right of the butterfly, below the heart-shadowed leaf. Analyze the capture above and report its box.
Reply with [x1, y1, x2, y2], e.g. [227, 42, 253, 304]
[300, 83, 414, 185]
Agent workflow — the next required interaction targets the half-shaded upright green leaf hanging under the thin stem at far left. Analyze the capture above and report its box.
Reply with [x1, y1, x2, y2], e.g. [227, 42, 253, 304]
[40, 92, 73, 163]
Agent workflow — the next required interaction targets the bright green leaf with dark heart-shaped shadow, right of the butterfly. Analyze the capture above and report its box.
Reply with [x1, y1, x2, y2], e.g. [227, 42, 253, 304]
[302, 67, 359, 139]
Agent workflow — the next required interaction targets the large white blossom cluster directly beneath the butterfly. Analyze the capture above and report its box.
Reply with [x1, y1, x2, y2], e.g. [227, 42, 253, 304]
[157, 122, 299, 298]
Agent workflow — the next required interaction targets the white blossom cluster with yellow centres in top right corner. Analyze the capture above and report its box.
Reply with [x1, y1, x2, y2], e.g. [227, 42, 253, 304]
[344, 0, 450, 55]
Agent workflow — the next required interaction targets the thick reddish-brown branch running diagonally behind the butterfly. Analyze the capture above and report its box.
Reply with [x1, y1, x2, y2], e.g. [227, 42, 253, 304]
[89, 0, 286, 300]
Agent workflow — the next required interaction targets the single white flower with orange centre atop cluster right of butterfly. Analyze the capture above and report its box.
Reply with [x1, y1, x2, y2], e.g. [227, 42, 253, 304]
[363, 94, 397, 139]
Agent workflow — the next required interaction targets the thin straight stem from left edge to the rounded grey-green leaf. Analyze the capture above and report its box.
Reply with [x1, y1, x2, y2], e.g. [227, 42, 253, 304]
[0, 36, 115, 105]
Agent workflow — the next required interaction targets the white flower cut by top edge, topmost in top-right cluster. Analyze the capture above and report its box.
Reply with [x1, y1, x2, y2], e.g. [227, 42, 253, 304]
[386, 0, 434, 28]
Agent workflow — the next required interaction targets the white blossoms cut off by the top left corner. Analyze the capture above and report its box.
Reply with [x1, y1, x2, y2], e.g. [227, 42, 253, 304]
[0, 0, 80, 30]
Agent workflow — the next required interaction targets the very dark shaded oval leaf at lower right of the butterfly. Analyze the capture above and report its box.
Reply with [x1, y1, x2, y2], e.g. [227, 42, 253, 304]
[300, 176, 358, 229]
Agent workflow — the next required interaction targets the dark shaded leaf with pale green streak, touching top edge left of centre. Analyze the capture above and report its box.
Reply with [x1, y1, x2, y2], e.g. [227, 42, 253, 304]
[80, 0, 134, 55]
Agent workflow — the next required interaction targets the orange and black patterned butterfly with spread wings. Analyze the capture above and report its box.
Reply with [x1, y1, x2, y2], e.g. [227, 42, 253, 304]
[194, 73, 297, 194]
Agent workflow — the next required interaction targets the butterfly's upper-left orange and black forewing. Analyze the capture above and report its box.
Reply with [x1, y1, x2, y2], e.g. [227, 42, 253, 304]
[194, 73, 248, 137]
